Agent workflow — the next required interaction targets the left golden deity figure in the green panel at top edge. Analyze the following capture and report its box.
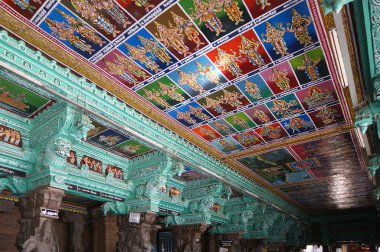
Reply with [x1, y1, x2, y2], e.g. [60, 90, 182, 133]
[190, 0, 226, 37]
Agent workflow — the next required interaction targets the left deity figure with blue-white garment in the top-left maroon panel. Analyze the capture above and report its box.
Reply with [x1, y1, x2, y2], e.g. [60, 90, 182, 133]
[71, 0, 120, 37]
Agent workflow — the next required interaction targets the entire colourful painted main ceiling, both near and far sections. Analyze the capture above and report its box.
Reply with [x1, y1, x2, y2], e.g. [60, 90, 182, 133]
[0, 0, 370, 209]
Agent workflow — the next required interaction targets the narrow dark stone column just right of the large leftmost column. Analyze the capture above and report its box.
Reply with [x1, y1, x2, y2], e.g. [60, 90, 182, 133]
[65, 211, 87, 252]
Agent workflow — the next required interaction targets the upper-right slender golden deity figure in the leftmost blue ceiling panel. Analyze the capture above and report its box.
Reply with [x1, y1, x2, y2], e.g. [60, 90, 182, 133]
[56, 9, 106, 46]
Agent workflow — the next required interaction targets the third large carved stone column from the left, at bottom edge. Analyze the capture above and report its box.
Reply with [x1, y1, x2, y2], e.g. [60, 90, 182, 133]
[173, 224, 208, 252]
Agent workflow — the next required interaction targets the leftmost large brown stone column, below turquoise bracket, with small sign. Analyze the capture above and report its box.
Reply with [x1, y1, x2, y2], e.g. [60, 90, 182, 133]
[16, 186, 64, 251]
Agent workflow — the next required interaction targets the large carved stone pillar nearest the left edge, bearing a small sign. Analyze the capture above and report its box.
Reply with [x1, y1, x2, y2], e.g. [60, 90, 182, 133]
[16, 187, 64, 251]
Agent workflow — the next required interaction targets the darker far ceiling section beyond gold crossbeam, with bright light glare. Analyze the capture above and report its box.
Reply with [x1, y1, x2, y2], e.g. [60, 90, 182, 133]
[238, 132, 371, 210]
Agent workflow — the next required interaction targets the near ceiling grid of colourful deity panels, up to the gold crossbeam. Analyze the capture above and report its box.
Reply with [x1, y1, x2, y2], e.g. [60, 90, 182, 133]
[1, 0, 349, 156]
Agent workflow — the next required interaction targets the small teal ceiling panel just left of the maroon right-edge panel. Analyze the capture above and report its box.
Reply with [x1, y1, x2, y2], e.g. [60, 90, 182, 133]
[266, 94, 303, 119]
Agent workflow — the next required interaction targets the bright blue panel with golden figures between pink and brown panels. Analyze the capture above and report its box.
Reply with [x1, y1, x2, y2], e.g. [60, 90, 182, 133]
[118, 29, 177, 74]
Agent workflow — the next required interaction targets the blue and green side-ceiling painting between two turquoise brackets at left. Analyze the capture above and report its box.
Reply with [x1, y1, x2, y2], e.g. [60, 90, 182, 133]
[86, 119, 153, 159]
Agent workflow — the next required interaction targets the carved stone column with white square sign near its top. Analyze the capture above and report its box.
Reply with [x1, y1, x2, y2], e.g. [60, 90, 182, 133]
[116, 212, 161, 252]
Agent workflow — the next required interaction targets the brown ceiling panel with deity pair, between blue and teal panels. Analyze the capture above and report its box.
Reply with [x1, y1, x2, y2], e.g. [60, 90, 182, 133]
[198, 85, 250, 116]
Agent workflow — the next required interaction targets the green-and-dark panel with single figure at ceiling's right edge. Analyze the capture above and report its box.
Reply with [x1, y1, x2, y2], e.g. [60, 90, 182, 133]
[289, 47, 329, 84]
